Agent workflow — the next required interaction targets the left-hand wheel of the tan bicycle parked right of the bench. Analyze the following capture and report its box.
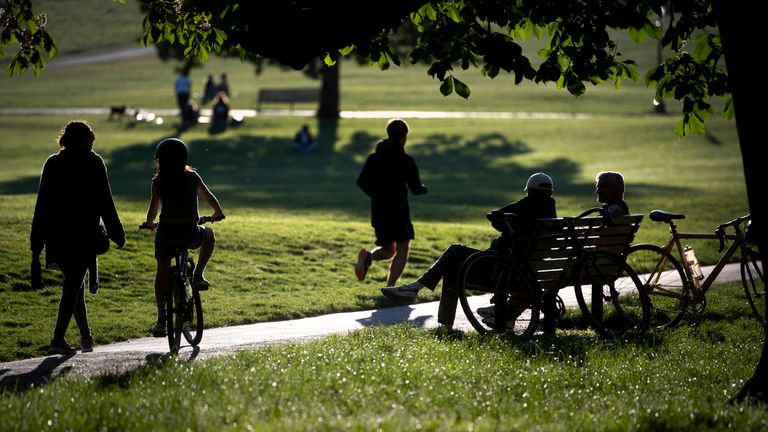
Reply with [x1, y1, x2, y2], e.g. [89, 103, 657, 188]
[626, 244, 690, 328]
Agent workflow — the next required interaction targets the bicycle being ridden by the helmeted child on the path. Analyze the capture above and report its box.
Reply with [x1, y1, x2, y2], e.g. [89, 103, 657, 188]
[139, 216, 220, 352]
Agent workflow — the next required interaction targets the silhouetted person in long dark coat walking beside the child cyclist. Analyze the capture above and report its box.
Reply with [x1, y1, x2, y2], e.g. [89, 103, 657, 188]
[29, 120, 125, 355]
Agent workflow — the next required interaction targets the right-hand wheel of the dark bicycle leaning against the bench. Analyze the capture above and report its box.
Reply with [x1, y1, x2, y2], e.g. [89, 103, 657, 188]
[574, 251, 651, 339]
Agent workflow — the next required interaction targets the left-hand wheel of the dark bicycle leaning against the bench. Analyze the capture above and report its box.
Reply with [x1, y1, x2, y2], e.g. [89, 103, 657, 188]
[459, 250, 541, 339]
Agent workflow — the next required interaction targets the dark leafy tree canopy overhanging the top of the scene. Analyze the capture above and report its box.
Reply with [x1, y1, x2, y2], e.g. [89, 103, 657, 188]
[0, 0, 733, 136]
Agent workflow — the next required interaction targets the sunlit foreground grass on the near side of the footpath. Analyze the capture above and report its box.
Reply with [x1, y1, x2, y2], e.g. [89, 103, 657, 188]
[0, 284, 768, 431]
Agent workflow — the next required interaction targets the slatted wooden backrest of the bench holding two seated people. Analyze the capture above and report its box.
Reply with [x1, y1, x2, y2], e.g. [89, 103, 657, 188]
[521, 214, 643, 290]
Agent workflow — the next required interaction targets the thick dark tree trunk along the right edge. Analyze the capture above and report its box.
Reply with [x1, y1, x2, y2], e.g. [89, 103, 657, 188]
[714, 0, 768, 402]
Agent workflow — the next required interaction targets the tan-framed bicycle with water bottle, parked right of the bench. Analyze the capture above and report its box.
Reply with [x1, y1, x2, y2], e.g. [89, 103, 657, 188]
[627, 210, 766, 328]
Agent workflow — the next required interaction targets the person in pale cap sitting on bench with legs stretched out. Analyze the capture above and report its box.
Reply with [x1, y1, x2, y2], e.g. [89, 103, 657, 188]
[381, 172, 557, 328]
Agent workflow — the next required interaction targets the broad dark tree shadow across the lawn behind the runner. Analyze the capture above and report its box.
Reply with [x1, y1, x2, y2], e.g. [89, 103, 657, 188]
[0, 126, 680, 224]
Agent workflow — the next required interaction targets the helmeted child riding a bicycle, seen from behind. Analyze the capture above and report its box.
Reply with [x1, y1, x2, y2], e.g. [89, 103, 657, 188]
[142, 138, 224, 337]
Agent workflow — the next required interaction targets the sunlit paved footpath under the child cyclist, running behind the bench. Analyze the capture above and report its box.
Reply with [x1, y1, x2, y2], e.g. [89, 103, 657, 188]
[0, 264, 741, 388]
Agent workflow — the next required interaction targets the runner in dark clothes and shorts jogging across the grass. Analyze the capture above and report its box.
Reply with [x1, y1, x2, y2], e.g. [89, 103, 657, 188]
[355, 118, 427, 285]
